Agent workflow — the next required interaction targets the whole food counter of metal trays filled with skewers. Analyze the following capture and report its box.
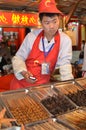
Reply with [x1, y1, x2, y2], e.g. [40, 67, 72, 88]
[0, 78, 86, 130]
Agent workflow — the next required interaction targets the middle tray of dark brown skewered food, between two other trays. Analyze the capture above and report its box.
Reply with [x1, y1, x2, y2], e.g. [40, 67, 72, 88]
[31, 85, 76, 116]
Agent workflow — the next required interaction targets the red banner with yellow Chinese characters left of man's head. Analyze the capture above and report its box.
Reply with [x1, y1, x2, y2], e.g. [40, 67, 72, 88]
[0, 11, 39, 27]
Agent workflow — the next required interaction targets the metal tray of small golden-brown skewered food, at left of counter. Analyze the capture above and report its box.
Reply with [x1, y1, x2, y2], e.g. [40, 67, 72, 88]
[0, 90, 51, 125]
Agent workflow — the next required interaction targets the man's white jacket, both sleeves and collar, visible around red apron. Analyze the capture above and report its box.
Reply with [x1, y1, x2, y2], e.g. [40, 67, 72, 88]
[12, 29, 73, 80]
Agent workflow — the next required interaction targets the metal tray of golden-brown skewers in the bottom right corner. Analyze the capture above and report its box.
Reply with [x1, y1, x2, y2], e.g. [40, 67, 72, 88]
[57, 108, 86, 130]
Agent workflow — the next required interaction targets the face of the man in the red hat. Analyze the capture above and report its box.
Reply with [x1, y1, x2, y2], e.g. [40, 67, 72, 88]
[41, 15, 59, 35]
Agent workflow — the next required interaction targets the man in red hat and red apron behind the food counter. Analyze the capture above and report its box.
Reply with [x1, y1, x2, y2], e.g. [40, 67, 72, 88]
[11, 0, 73, 89]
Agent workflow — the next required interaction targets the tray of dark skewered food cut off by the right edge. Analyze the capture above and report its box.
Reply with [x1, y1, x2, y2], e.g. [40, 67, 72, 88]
[55, 81, 86, 107]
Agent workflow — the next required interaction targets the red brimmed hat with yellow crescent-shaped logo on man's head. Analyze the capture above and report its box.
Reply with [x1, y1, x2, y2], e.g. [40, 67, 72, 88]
[39, 0, 63, 15]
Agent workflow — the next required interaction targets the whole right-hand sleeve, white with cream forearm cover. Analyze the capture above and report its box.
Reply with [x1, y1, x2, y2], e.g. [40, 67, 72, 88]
[56, 33, 73, 81]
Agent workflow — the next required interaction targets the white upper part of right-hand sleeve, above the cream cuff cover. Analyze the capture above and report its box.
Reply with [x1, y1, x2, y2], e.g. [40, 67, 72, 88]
[56, 33, 72, 66]
